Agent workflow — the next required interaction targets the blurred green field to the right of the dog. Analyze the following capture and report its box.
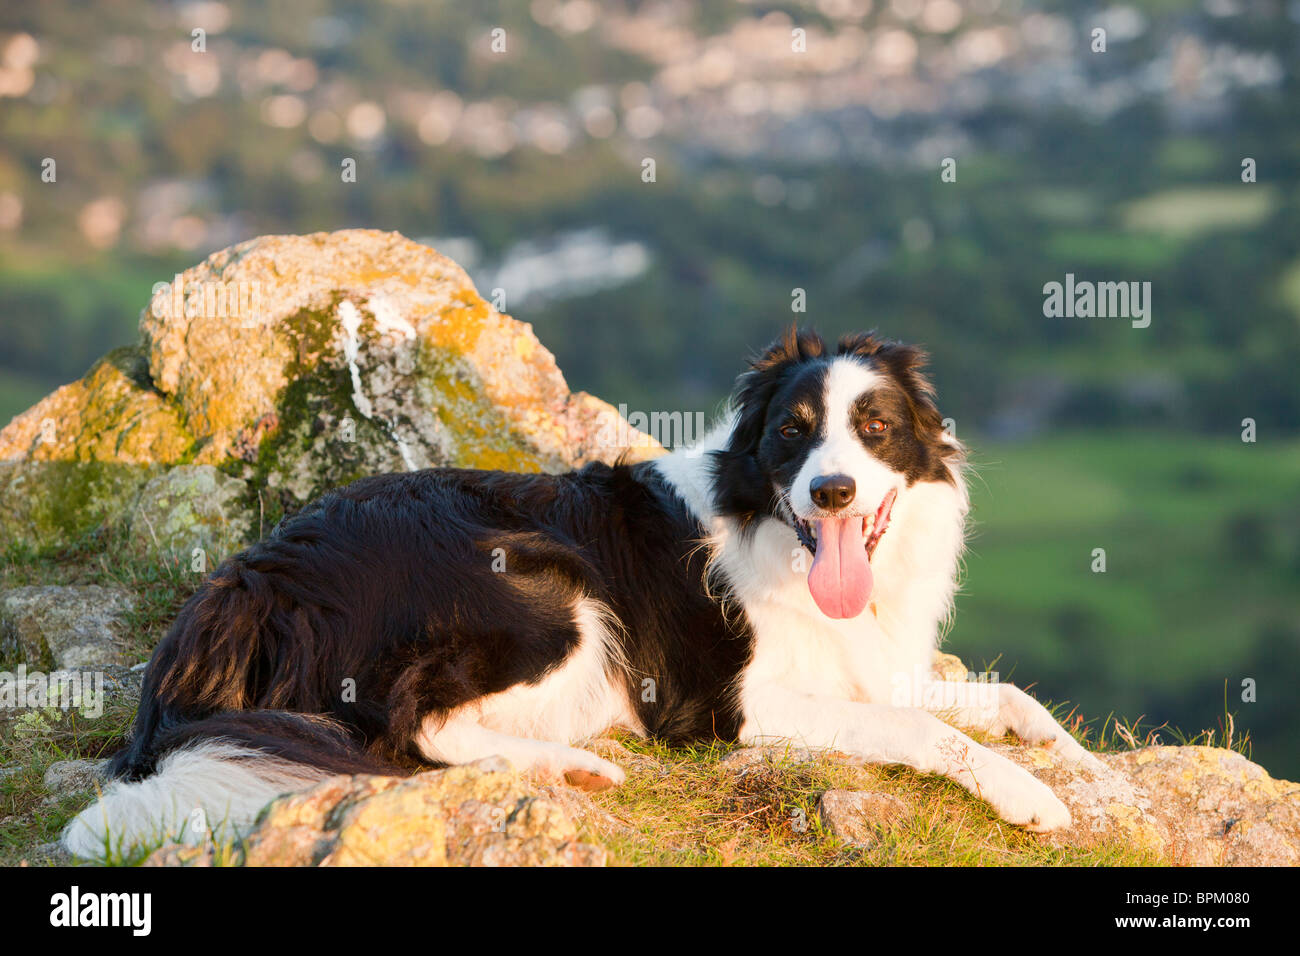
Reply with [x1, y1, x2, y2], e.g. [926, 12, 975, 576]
[946, 433, 1300, 779]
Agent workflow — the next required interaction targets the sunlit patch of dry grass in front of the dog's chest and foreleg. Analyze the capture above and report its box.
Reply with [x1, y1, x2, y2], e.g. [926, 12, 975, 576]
[586, 736, 1160, 866]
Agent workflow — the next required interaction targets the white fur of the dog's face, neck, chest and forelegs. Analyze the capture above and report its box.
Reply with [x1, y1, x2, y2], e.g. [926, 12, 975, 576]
[659, 359, 1093, 830]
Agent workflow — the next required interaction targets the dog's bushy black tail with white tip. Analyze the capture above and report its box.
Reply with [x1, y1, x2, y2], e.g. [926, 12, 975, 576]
[62, 705, 402, 860]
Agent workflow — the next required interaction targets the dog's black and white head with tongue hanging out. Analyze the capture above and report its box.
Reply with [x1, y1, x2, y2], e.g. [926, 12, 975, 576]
[714, 328, 961, 618]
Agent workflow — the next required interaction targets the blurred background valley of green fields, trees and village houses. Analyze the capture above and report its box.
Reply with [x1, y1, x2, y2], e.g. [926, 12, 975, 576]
[0, 0, 1300, 778]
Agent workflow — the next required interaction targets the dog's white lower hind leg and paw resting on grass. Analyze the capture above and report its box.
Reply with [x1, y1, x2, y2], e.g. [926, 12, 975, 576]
[415, 713, 625, 790]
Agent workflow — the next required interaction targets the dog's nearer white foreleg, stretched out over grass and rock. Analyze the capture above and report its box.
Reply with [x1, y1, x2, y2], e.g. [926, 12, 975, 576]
[740, 684, 1070, 832]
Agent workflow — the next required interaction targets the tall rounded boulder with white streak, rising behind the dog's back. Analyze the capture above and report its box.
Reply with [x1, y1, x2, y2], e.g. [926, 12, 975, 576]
[140, 230, 660, 501]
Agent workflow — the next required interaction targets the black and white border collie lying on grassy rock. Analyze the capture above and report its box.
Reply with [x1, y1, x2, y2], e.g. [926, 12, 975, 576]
[65, 329, 1095, 857]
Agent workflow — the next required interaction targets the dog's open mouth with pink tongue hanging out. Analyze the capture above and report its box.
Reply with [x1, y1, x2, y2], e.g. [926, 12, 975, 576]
[794, 489, 898, 618]
